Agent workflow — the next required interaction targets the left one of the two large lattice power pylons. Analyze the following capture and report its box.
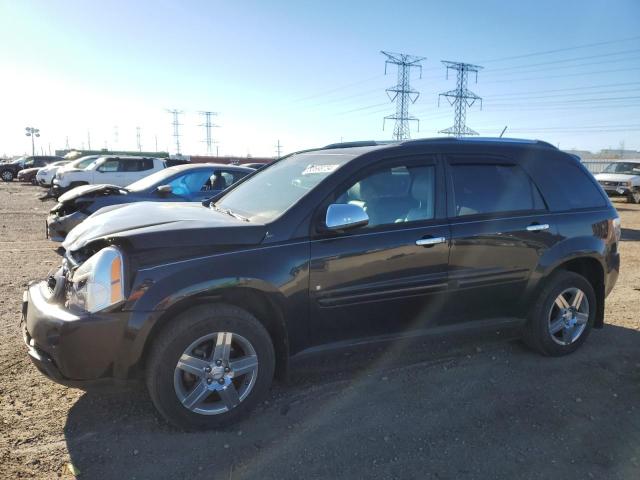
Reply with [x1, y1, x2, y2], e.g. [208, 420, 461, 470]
[380, 51, 426, 140]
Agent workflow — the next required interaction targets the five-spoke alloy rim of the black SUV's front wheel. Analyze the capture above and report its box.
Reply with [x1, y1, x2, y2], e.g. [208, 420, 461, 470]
[173, 332, 258, 415]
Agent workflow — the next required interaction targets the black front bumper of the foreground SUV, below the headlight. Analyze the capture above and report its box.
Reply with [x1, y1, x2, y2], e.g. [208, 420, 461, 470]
[22, 282, 127, 388]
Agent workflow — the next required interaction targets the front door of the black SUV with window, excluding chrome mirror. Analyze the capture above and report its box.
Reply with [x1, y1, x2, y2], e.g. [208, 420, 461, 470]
[309, 156, 450, 344]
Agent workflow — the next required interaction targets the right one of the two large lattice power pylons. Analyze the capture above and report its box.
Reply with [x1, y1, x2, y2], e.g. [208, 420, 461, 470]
[438, 60, 482, 138]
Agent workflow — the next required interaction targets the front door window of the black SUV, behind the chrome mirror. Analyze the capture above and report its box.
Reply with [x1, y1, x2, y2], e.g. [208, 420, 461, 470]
[335, 165, 436, 227]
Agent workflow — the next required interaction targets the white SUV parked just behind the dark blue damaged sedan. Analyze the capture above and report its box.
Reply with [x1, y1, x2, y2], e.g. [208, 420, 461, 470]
[53, 156, 166, 191]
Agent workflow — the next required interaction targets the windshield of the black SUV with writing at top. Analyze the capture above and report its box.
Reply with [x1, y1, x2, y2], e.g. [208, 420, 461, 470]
[212, 152, 353, 222]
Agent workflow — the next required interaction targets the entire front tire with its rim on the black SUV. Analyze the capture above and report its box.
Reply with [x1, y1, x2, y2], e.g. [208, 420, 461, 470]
[146, 304, 275, 430]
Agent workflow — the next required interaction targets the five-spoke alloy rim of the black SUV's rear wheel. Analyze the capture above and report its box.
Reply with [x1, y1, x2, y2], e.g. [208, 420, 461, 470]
[549, 287, 589, 345]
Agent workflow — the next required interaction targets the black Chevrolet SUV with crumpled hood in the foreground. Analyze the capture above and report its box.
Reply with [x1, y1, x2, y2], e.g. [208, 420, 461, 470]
[23, 139, 620, 428]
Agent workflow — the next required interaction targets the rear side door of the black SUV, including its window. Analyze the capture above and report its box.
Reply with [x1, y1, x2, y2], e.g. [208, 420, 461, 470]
[447, 156, 558, 320]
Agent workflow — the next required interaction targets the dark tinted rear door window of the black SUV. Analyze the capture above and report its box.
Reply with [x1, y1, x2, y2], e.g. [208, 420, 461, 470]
[451, 164, 545, 217]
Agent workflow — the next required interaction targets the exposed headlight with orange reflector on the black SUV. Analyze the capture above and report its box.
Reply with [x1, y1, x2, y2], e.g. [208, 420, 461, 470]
[68, 247, 124, 313]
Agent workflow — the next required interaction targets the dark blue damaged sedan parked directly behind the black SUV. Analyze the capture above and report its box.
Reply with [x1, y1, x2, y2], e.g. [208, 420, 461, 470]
[47, 163, 254, 242]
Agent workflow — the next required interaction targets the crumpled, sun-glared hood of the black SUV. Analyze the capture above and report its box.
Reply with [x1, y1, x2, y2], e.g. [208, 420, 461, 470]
[62, 202, 267, 251]
